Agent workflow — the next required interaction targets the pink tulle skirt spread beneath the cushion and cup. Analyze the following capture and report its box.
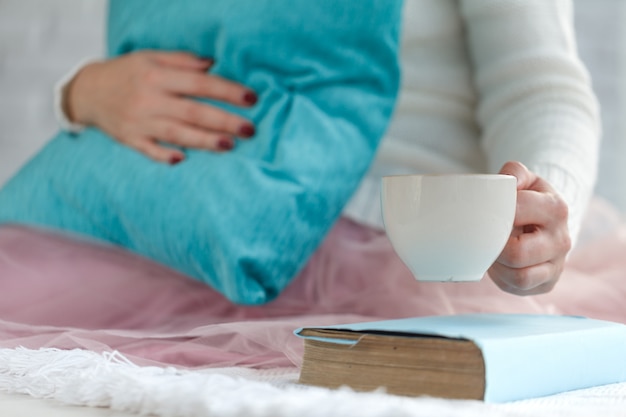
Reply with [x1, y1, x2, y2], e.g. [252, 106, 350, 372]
[0, 201, 626, 367]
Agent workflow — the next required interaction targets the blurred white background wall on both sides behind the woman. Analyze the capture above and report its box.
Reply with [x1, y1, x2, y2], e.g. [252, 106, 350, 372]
[0, 0, 626, 213]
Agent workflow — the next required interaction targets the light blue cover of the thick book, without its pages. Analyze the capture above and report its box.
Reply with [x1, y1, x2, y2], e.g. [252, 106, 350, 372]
[295, 314, 626, 402]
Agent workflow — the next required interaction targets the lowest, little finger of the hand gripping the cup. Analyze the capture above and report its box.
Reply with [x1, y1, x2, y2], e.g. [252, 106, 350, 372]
[488, 262, 559, 295]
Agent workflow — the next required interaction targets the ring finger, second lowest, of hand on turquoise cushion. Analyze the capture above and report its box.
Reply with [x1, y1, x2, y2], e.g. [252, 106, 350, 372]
[150, 119, 235, 151]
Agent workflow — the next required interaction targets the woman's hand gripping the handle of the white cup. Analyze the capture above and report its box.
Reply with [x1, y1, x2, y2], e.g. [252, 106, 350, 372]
[488, 162, 571, 295]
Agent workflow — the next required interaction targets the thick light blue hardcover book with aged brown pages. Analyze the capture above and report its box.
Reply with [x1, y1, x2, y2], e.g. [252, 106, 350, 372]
[295, 314, 626, 402]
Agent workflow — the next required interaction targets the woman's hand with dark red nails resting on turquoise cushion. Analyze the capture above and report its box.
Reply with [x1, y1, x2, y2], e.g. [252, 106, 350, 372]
[63, 51, 257, 164]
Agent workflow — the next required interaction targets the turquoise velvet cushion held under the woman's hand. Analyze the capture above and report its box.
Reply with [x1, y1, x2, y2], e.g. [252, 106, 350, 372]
[0, 0, 402, 304]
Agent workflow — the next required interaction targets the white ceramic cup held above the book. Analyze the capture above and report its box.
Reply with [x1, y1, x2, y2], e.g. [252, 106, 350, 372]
[381, 174, 517, 281]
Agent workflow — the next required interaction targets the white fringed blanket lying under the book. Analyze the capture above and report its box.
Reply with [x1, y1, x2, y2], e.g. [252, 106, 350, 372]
[0, 348, 626, 417]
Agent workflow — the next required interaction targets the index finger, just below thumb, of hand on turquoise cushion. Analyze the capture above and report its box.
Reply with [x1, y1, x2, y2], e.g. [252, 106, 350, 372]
[157, 70, 258, 107]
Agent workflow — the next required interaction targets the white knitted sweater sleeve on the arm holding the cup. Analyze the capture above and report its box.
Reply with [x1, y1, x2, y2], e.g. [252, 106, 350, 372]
[460, 0, 600, 242]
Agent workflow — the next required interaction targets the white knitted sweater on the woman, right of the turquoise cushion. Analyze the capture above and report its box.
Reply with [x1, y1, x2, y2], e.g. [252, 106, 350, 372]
[344, 0, 600, 244]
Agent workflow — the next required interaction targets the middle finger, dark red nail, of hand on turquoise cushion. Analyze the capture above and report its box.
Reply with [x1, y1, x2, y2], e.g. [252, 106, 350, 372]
[161, 98, 255, 138]
